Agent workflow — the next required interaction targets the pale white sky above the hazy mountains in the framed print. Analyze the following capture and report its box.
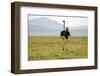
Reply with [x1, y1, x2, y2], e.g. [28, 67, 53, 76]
[29, 15, 88, 27]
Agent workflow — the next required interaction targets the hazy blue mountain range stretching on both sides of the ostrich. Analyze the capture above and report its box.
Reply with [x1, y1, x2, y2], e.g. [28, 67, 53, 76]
[29, 17, 88, 36]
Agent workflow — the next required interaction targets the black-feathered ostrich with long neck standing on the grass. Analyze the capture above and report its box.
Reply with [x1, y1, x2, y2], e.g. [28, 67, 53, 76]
[60, 20, 70, 50]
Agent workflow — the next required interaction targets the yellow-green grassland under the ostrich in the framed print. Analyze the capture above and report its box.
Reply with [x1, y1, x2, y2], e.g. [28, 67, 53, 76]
[28, 36, 88, 60]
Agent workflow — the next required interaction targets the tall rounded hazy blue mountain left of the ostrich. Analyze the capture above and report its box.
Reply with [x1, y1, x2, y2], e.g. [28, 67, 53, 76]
[29, 17, 62, 35]
